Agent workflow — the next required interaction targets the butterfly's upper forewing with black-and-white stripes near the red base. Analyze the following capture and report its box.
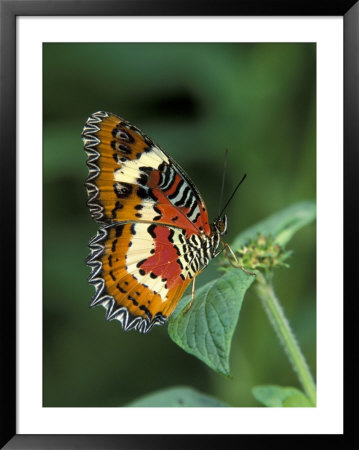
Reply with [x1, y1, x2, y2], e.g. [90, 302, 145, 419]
[82, 111, 211, 235]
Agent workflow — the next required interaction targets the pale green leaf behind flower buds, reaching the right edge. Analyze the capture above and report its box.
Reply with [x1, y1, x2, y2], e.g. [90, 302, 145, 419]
[232, 201, 316, 250]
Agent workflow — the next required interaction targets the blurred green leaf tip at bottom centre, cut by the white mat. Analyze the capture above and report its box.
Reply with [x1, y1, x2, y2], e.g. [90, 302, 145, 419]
[126, 386, 229, 408]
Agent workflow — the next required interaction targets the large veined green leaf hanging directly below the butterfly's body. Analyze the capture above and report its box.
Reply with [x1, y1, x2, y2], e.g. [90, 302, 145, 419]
[168, 268, 255, 376]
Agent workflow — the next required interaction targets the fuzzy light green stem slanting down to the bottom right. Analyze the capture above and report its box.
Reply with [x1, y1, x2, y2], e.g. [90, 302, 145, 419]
[255, 273, 316, 406]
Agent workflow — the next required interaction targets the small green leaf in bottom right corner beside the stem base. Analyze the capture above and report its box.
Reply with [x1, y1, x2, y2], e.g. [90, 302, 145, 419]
[252, 385, 313, 407]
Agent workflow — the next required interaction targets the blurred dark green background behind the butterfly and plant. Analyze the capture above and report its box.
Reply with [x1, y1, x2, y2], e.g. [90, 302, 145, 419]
[43, 43, 316, 407]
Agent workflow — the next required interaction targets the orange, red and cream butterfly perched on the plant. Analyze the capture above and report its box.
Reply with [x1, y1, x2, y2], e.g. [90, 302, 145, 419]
[82, 111, 227, 333]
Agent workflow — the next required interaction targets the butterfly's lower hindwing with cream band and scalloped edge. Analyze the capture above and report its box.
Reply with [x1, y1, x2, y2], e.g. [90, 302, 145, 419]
[87, 222, 193, 332]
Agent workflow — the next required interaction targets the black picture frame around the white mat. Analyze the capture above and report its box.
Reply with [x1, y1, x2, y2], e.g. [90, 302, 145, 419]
[0, 0, 359, 449]
